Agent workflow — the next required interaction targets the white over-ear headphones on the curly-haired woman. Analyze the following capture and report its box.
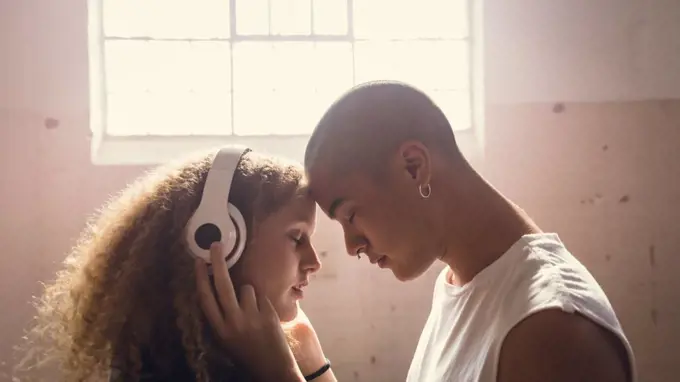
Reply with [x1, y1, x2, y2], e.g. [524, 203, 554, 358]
[186, 146, 250, 268]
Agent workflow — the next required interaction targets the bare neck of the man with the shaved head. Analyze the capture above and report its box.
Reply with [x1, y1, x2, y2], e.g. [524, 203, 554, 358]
[432, 169, 541, 285]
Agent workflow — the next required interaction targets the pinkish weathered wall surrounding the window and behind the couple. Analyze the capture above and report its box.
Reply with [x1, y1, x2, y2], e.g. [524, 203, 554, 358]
[0, 0, 680, 382]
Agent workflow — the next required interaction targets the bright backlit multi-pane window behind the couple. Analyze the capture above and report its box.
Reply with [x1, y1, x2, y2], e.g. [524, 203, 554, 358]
[89, 0, 481, 164]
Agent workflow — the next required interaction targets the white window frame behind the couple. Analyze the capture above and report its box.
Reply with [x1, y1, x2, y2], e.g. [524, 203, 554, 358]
[88, 0, 484, 167]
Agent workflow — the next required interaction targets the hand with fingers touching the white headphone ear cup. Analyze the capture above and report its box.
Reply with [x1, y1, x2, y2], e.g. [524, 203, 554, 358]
[196, 243, 305, 382]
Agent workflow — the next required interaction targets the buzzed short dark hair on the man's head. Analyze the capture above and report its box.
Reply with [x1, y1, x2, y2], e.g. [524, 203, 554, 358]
[305, 81, 461, 176]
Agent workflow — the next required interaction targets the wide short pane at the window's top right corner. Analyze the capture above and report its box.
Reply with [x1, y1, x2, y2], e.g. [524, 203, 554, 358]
[354, 0, 468, 39]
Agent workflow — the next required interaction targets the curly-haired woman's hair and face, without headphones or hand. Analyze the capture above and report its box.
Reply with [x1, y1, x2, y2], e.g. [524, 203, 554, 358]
[19, 152, 334, 381]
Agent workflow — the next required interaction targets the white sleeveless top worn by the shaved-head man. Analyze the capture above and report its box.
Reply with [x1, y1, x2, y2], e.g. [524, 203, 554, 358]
[407, 234, 637, 382]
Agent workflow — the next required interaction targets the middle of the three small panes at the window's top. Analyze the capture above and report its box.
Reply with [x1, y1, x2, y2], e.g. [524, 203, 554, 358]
[270, 0, 312, 35]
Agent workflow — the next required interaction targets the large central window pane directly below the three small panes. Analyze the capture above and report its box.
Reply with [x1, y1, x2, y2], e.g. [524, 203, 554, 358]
[234, 42, 352, 135]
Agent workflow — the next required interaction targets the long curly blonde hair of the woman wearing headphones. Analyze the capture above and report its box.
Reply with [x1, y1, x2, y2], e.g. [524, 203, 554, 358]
[17, 152, 305, 381]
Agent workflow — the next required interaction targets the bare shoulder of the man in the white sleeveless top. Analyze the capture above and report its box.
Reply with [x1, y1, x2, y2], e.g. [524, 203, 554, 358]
[497, 309, 631, 382]
